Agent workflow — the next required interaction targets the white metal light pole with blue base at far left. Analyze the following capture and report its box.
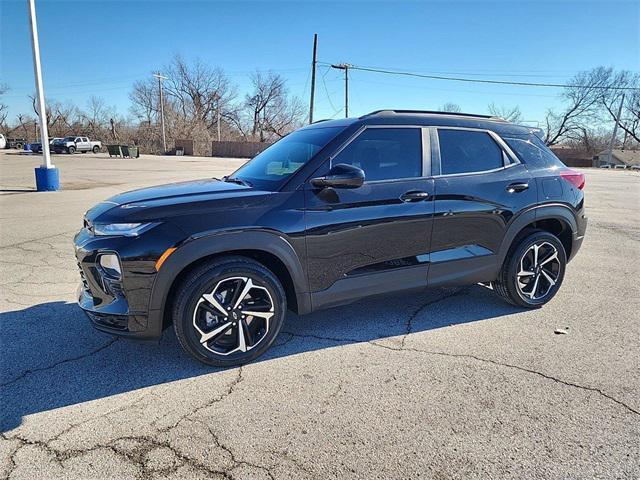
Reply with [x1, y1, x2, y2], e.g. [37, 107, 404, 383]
[27, 0, 60, 191]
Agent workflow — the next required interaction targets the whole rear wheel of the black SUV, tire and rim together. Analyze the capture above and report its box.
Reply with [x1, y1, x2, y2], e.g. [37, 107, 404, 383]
[493, 230, 567, 308]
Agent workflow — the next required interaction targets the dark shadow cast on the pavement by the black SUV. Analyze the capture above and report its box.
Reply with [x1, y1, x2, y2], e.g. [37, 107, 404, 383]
[0, 285, 521, 432]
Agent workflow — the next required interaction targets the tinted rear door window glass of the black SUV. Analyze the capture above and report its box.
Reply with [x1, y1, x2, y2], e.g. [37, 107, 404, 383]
[438, 129, 504, 175]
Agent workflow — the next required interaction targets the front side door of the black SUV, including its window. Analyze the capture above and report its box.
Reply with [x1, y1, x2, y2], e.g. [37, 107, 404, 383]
[305, 126, 433, 308]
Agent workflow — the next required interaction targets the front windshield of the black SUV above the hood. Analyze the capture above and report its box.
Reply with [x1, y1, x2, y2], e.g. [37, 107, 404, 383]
[231, 127, 344, 190]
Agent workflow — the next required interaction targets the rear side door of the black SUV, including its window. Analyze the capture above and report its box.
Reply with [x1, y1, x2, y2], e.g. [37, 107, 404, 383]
[429, 127, 537, 285]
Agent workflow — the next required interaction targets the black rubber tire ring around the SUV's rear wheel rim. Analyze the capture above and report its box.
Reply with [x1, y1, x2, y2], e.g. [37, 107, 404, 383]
[506, 232, 567, 308]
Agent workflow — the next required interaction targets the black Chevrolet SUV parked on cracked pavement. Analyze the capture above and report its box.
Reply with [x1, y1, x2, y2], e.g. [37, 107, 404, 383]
[75, 110, 587, 366]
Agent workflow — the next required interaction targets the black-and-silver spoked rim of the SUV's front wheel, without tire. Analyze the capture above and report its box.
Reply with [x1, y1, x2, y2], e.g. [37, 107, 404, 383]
[193, 277, 275, 355]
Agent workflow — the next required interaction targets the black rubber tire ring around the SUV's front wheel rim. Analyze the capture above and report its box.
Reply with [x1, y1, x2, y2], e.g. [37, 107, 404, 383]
[173, 260, 287, 367]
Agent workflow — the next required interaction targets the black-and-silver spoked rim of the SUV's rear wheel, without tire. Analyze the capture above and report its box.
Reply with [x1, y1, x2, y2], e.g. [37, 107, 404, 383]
[516, 242, 561, 300]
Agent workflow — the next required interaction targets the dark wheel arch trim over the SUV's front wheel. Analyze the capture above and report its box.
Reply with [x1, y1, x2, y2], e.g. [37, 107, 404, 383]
[149, 230, 310, 332]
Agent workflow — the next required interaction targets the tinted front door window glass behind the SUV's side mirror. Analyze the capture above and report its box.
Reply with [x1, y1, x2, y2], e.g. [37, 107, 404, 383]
[331, 128, 422, 181]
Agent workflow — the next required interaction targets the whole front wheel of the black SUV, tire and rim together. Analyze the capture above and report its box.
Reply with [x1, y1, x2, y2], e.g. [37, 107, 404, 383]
[172, 256, 287, 367]
